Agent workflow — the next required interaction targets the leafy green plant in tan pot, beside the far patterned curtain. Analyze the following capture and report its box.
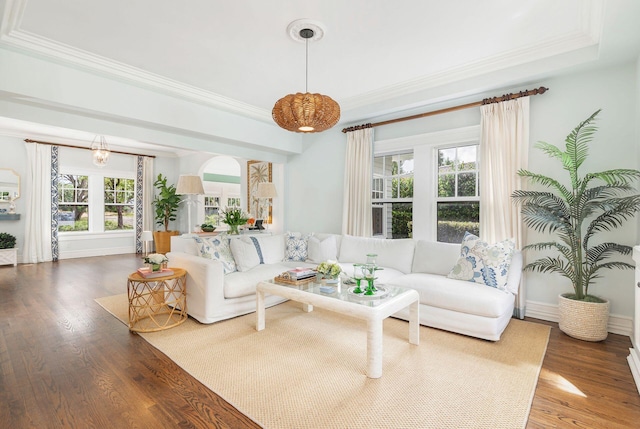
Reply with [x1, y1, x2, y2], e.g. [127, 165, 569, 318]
[153, 174, 180, 254]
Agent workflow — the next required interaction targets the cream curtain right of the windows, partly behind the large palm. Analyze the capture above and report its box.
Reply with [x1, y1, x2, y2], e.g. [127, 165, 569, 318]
[480, 97, 529, 318]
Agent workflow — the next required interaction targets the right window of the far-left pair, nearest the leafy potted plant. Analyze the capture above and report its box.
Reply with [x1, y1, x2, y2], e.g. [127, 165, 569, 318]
[104, 177, 136, 231]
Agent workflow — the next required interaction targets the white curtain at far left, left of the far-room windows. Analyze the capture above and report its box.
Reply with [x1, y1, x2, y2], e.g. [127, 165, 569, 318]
[22, 143, 52, 264]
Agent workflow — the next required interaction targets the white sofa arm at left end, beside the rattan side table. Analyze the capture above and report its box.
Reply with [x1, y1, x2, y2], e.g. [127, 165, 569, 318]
[167, 252, 224, 323]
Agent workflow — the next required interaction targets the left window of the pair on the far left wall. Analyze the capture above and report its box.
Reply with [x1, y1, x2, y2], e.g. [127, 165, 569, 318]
[58, 174, 89, 231]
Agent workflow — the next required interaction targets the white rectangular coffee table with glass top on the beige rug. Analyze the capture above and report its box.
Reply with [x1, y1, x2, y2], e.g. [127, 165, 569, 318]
[256, 281, 420, 378]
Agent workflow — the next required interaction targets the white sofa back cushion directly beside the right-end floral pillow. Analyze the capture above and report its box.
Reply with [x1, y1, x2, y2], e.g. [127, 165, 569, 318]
[411, 240, 460, 276]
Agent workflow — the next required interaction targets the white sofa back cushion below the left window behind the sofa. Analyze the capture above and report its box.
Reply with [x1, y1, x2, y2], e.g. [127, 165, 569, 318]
[339, 235, 416, 274]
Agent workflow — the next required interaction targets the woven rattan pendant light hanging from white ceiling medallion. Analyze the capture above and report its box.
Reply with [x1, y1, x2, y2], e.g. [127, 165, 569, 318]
[271, 20, 340, 133]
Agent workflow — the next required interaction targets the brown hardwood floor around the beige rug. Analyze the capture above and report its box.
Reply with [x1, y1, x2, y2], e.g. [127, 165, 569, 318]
[0, 255, 640, 428]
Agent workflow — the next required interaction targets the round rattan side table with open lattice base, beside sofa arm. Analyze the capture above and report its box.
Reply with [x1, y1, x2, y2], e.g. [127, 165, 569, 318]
[127, 268, 188, 332]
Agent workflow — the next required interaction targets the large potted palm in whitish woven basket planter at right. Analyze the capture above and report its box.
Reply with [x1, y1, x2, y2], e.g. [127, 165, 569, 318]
[512, 110, 640, 341]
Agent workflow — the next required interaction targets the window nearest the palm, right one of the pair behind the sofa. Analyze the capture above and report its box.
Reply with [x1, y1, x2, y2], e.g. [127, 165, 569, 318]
[436, 145, 480, 243]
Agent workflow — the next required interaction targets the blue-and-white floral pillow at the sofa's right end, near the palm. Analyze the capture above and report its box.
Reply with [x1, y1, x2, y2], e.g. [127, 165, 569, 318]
[447, 232, 515, 290]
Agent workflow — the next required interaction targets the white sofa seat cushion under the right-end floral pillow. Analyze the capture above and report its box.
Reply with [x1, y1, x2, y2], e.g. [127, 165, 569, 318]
[384, 273, 515, 317]
